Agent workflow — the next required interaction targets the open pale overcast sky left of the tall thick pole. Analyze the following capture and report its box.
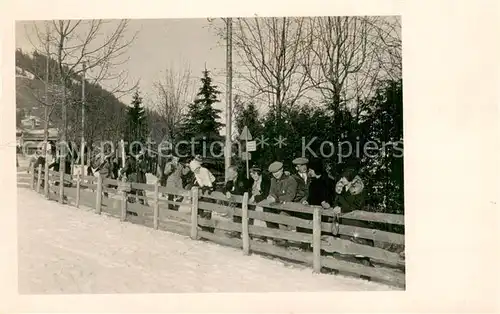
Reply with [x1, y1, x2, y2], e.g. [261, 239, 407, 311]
[16, 19, 226, 118]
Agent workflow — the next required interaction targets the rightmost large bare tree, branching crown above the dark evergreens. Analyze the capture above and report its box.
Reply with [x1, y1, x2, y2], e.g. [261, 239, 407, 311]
[302, 16, 401, 110]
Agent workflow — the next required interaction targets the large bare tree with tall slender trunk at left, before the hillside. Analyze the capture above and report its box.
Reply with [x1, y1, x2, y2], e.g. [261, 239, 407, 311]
[23, 20, 136, 191]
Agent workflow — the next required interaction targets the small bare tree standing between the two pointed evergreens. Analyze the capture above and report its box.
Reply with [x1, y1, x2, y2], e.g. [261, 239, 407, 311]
[154, 67, 195, 140]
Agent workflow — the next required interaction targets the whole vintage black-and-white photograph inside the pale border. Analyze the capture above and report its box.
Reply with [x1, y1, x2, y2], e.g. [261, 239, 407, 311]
[15, 16, 406, 295]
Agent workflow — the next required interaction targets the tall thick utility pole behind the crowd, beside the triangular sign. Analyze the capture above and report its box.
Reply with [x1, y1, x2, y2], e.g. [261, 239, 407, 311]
[224, 18, 233, 182]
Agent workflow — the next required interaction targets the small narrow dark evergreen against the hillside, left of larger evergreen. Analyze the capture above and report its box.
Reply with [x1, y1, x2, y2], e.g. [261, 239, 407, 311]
[125, 91, 147, 154]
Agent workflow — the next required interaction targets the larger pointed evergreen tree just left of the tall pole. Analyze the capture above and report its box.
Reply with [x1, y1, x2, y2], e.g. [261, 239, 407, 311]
[181, 70, 223, 139]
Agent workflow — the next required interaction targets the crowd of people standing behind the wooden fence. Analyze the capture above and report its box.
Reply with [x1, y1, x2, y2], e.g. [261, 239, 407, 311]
[26, 146, 364, 232]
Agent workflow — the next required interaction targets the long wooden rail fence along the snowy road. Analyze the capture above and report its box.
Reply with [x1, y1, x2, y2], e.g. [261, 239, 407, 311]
[25, 168, 405, 288]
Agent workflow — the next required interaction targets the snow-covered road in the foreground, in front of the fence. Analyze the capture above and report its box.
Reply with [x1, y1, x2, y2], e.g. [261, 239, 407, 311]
[18, 188, 390, 294]
